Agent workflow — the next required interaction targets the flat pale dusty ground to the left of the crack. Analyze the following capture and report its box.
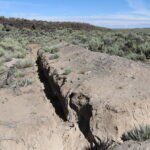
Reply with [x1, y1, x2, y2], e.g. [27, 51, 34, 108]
[0, 45, 88, 150]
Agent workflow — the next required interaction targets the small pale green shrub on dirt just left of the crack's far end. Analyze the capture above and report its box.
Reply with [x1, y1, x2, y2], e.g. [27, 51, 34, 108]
[15, 59, 34, 69]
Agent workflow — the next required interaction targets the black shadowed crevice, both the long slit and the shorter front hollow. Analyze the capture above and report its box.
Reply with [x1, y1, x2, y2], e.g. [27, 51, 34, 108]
[37, 55, 96, 145]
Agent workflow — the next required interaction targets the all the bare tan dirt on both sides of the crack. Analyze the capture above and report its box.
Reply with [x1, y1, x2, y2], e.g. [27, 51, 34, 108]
[0, 43, 150, 150]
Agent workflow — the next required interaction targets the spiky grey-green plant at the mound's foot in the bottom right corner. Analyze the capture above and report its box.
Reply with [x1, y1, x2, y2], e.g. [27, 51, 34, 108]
[122, 125, 150, 141]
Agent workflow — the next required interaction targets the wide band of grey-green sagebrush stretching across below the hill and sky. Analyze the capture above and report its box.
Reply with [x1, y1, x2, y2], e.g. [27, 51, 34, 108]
[0, 18, 150, 61]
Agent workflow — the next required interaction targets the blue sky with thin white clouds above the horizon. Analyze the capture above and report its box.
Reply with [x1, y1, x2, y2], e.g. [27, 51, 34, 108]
[0, 0, 150, 28]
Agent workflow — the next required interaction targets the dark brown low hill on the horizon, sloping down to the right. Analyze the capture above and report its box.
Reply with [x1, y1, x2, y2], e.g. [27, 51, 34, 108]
[0, 17, 110, 31]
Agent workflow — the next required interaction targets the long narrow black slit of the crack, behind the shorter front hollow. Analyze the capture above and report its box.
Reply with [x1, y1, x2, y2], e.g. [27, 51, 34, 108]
[36, 58, 67, 121]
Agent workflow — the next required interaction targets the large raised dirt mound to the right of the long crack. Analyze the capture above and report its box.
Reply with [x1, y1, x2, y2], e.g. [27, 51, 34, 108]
[39, 44, 150, 142]
